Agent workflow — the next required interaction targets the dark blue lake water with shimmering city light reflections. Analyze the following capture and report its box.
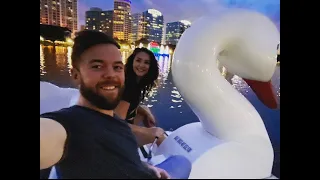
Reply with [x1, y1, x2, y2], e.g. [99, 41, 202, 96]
[40, 45, 280, 177]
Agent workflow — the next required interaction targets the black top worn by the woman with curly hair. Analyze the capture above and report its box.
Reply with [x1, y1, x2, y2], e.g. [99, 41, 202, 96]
[122, 80, 141, 123]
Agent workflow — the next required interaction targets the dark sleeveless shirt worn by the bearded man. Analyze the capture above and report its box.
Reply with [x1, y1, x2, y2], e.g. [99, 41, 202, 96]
[40, 106, 156, 179]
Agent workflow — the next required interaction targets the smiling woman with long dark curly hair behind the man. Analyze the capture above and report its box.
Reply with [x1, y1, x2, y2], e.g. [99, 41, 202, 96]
[115, 48, 164, 145]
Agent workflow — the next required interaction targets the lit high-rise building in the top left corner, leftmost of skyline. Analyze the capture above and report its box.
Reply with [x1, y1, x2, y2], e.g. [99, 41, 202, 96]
[40, 0, 78, 33]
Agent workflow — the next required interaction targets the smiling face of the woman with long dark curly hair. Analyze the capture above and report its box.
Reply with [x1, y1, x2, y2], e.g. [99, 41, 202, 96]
[133, 52, 150, 77]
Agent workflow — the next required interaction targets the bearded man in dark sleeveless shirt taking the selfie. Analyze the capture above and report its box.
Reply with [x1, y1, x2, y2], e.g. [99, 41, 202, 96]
[40, 31, 191, 179]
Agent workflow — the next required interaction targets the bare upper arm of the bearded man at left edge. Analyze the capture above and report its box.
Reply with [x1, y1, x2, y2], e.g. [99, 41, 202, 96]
[40, 118, 67, 170]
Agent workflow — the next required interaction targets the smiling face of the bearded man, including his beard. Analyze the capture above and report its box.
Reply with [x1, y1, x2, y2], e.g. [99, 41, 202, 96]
[73, 44, 125, 110]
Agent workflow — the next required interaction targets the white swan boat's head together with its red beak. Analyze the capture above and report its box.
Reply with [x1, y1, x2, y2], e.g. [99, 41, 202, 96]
[217, 10, 280, 109]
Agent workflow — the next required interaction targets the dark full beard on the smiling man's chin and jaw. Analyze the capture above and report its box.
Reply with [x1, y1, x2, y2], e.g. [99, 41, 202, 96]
[80, 81, 124, 110]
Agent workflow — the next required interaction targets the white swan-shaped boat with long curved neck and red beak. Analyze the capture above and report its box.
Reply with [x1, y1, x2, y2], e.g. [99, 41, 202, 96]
[40, 9, 280, 179]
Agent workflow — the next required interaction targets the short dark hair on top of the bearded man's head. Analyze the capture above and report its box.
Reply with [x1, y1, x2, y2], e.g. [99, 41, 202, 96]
[71, 30, 120, 68]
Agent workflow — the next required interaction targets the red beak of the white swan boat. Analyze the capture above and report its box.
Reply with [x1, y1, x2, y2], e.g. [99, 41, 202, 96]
[243, 79, 278, 109]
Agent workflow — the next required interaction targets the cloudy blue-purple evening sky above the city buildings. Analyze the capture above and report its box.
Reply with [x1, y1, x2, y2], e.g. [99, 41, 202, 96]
[78, 0, 280, 28]
